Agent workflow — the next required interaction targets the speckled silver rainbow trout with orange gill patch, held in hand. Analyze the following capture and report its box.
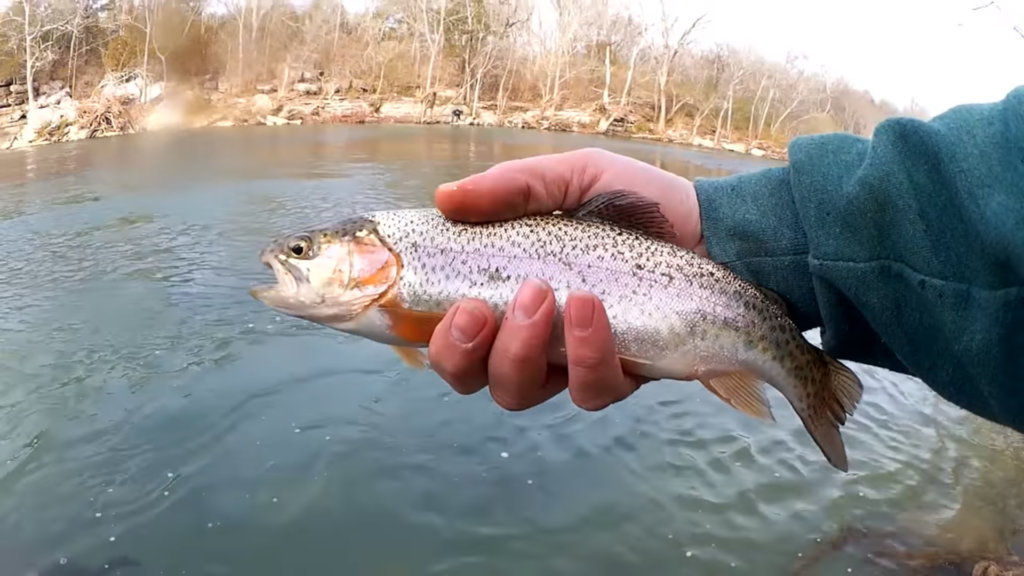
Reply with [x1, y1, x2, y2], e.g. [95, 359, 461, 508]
[249, 190, 863, 472]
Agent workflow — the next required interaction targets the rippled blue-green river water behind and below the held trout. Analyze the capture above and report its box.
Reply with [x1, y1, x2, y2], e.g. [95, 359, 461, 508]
[0, 125, 1024, 576]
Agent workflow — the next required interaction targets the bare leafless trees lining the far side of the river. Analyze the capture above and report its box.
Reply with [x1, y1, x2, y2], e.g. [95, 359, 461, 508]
[0, 0, 925, 145]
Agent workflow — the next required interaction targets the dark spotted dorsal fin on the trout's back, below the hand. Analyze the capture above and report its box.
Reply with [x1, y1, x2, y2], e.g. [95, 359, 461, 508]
[563, 190, 679, 243]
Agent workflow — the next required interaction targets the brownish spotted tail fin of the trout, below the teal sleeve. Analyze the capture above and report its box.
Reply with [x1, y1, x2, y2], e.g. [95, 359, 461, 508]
[793, 351, 864, 471]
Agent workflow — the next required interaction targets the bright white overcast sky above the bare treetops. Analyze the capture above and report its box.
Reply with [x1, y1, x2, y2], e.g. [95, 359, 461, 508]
[342, 0, 1024, 115]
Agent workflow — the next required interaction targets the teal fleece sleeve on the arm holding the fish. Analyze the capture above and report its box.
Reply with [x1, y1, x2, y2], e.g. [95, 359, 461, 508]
[694, 86, 1024, 431]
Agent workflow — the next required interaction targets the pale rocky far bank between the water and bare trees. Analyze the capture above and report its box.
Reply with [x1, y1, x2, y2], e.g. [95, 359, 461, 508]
[0, 77, 786, 160]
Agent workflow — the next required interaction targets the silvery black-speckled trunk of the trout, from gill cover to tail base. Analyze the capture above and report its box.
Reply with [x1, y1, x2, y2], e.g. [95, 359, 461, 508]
[367, 209, 799, 363]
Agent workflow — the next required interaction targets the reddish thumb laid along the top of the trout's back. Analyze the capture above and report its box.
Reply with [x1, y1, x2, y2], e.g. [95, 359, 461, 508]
[434, 149, 607, 221]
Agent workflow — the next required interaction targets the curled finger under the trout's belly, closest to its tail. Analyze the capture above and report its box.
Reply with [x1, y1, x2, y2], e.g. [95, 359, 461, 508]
[565, 291, 638, 410]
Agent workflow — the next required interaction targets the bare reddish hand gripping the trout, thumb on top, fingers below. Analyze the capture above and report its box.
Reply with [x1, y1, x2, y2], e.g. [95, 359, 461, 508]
[429, 149, 707, 410]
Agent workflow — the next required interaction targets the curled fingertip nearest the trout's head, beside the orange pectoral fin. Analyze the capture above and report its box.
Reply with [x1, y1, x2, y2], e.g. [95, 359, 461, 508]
[428, 299, 498, 394]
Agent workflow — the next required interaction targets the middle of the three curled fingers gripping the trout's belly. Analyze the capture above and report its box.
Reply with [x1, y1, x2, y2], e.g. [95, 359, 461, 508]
[487, 280, 566, 410]
